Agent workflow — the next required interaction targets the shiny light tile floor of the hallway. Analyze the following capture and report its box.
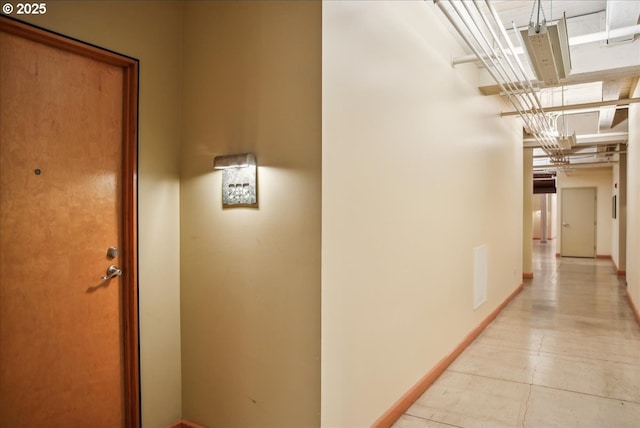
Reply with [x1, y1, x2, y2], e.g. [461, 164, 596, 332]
[394, 242, 640, 428]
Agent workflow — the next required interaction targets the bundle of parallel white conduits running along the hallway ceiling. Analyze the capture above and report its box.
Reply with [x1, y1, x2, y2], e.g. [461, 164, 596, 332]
[433, 0, 567, 164]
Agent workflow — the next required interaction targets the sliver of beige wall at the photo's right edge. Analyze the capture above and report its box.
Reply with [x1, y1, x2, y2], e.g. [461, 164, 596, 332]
[627, 79, 640, 310]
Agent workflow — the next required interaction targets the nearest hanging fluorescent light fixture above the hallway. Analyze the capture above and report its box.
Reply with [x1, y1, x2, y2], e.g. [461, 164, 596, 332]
[520, 16, 571, 85]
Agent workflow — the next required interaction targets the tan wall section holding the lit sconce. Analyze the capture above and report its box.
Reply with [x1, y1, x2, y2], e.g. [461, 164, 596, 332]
[181, 1, 322, 427]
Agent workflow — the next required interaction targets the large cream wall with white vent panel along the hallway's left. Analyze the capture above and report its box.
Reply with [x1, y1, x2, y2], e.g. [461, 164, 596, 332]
[322, 2, 530, 427]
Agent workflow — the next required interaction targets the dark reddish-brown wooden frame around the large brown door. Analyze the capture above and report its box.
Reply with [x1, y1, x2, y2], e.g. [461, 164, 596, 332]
[0, 15, 141, 427]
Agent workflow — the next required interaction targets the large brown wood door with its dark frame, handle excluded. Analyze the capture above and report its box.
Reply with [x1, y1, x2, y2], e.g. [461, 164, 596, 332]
[0, 19, 139, 427]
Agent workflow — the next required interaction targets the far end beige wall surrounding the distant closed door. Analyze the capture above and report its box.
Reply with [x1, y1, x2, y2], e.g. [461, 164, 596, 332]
[556, 167, 613, 256]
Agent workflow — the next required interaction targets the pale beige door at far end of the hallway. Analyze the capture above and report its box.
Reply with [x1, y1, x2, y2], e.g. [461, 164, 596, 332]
[560, 187, 596, 257]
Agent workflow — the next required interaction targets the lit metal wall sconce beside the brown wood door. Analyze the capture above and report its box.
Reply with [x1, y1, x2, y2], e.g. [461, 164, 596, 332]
[213, 153, 258, 207]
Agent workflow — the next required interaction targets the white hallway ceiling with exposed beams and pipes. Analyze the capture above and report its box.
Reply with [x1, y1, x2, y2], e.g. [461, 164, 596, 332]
[440, 0, 640, 170]
